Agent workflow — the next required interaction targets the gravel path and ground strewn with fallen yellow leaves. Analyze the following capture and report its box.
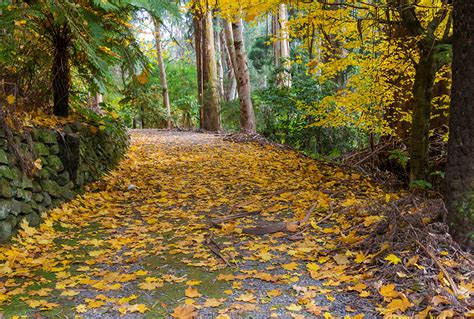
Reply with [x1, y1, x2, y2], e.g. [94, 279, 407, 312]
[0, 130, 473, 319]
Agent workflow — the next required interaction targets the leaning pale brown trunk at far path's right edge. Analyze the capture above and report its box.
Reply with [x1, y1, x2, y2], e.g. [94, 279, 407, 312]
[232, 19, 256, 133]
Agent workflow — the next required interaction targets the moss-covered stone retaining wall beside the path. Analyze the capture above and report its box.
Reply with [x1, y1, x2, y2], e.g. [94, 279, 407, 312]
[0, 123, 128, 242]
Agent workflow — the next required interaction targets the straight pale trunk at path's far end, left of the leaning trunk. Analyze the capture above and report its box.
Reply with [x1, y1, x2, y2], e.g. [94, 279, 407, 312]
[203, 10, 221, 132]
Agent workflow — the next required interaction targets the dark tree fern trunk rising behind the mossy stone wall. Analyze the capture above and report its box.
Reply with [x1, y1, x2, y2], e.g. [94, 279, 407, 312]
[51, 23, 71, 116]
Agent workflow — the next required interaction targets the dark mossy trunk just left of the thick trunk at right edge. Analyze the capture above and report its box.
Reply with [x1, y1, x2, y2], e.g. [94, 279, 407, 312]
[410, 51, 436, 181]
